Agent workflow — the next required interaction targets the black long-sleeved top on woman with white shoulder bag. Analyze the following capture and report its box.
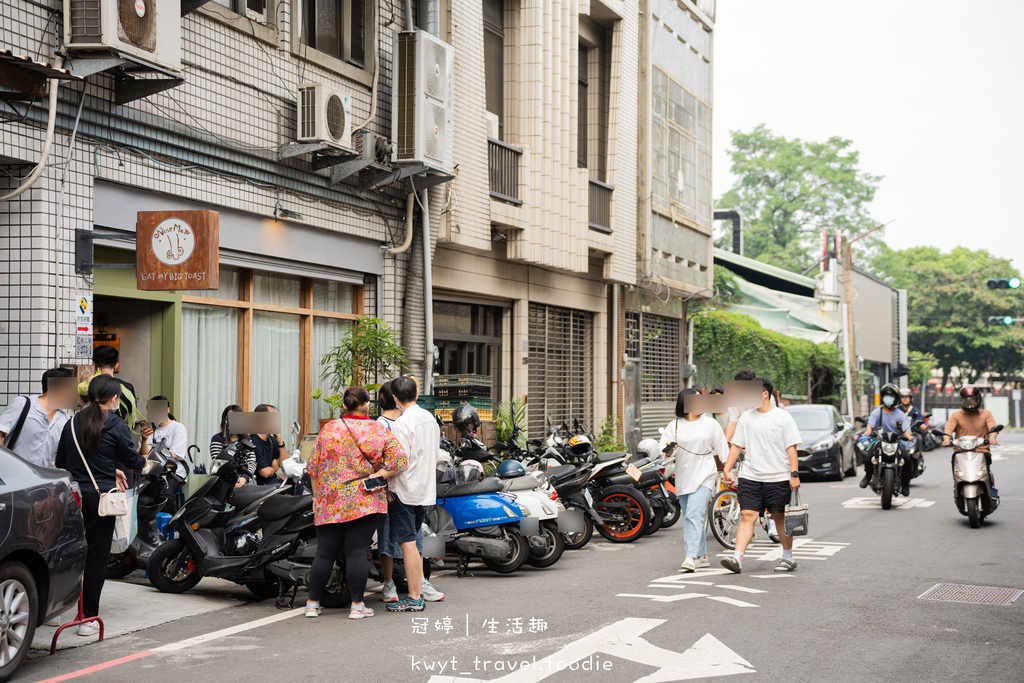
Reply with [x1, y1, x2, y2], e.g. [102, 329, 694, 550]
[53, 411, 145, 493]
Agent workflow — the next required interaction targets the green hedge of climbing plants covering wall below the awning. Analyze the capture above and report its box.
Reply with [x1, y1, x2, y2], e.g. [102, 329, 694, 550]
[693, 310, 843, 402]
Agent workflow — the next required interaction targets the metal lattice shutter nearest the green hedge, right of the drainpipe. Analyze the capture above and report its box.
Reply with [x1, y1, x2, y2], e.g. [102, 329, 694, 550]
[640, 313, 683, 438]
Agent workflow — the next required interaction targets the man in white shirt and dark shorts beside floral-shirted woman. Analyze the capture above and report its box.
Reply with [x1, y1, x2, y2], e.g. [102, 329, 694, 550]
[385, 375, 441, 612]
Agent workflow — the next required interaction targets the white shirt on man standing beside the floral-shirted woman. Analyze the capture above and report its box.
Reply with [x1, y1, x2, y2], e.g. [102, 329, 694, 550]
[388, 403, 441, 505]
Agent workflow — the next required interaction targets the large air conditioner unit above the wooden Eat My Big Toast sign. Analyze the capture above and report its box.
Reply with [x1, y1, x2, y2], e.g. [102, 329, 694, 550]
[63, 0, 181, 71]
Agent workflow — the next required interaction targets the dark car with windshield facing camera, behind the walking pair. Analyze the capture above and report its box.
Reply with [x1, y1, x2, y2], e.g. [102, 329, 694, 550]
[785, 405, 857, 481]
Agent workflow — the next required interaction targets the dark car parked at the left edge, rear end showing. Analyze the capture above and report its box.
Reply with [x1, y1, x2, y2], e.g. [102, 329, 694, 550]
[0, 446, 86, 681]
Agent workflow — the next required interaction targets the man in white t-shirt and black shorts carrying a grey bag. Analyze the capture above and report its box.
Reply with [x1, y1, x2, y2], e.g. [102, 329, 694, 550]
[722, 378, 802, 573]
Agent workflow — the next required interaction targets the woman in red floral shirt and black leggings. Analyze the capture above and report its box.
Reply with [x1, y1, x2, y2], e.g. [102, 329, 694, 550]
[306, 387, 409, 618]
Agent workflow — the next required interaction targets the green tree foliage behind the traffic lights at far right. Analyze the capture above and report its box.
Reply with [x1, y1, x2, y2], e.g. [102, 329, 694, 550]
[874, 247, 1024, 385]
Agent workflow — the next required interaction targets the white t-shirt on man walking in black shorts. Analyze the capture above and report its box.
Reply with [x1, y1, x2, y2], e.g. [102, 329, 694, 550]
[732, 408, 803, 481]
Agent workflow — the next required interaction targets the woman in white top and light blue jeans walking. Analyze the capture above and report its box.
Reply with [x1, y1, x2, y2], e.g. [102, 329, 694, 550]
[662, 389, 729, 572]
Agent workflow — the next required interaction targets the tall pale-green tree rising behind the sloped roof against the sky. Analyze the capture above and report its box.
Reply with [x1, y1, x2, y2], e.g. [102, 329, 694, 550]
[716, 124, 882, 272]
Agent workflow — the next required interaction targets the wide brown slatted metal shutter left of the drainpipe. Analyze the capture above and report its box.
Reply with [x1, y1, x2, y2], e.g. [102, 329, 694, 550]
[527, 303, 594, 438]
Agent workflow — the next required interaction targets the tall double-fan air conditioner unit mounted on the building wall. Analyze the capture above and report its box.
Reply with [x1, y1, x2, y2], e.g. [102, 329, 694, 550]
[391, 31, 455, 173]
